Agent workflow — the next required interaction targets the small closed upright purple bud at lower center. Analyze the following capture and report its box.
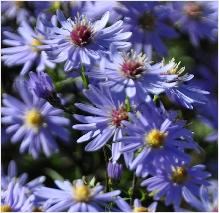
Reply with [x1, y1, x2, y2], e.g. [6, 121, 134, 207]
[107, 162, 122, 181]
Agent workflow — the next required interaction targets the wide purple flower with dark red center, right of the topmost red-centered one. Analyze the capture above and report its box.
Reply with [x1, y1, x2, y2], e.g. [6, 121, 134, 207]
[87, 50, 178, 101]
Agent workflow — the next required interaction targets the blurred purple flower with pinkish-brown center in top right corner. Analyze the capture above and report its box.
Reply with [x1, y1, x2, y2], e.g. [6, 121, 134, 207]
[170, 1, 217, 46]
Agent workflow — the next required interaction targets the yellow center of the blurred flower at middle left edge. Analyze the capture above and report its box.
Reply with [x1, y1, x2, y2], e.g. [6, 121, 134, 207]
[25, 109, 43, 128]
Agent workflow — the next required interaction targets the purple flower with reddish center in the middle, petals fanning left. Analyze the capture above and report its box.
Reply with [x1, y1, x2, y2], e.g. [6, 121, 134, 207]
[73, 85, 128, 154]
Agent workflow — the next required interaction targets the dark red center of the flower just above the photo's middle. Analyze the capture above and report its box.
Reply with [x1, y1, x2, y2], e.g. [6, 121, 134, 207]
[121, 60, 143, 78]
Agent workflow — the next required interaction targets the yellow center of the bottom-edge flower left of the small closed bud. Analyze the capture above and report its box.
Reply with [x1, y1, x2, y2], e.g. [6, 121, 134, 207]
[73, 185, 90, 202]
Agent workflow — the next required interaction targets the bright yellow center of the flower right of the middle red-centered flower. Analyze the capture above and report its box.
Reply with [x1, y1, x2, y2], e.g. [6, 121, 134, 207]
[145, 129, 166, 148]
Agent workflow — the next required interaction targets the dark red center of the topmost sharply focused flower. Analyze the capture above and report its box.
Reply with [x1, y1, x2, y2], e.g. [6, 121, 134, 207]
[70, 25, 92, 46]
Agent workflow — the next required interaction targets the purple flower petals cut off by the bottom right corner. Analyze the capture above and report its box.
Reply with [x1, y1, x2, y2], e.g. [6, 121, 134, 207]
[176, 181, 218, 212]
